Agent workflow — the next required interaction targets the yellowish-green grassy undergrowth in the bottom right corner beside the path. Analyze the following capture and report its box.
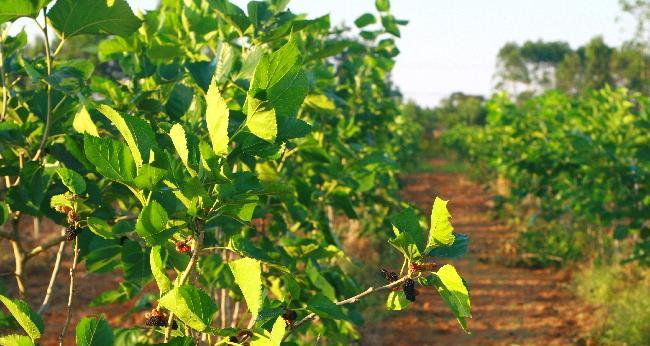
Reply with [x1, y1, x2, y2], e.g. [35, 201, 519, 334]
[574, 264, 650, 345]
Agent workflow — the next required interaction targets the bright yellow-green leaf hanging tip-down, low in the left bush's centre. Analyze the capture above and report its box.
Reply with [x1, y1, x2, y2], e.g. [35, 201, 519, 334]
[228, 258, 263, 320]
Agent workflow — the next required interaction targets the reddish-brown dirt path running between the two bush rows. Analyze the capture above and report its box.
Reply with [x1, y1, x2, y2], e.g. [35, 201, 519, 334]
[363, 160, 590, 346]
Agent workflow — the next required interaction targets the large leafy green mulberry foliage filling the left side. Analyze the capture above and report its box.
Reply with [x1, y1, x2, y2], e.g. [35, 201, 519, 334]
[0, 0, 470, 345]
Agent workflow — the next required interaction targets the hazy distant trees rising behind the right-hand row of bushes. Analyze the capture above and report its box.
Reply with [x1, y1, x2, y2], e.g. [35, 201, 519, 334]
[404, 0, 650, 130]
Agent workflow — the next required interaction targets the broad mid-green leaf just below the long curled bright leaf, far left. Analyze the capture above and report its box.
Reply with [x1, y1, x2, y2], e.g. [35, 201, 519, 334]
[84, 135, 136, 183]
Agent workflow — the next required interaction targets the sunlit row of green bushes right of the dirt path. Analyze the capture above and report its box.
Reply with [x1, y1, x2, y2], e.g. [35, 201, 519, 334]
[445, 88, 650, 264]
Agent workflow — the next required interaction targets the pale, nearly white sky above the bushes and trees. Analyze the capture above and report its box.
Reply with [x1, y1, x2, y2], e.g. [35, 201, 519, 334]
[10, 0, 634, 105]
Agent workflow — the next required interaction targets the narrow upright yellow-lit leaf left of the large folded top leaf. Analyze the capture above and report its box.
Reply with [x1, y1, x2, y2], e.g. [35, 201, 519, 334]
[205, 80, 230, 156]
